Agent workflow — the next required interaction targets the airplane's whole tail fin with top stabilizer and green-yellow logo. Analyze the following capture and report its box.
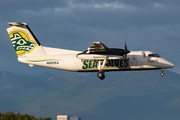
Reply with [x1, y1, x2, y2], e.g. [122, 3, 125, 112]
[7, 22, 46, 57]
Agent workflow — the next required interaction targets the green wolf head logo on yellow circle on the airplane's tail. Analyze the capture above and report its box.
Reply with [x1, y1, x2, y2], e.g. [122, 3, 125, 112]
[9, 31, 36, 57]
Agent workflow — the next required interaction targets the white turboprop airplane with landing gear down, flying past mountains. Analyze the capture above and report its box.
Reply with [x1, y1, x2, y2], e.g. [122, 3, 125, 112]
[7, 22, 174, 80]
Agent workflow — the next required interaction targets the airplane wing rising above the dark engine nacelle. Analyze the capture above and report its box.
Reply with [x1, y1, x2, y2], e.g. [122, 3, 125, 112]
[87, 42, 110, 53]
